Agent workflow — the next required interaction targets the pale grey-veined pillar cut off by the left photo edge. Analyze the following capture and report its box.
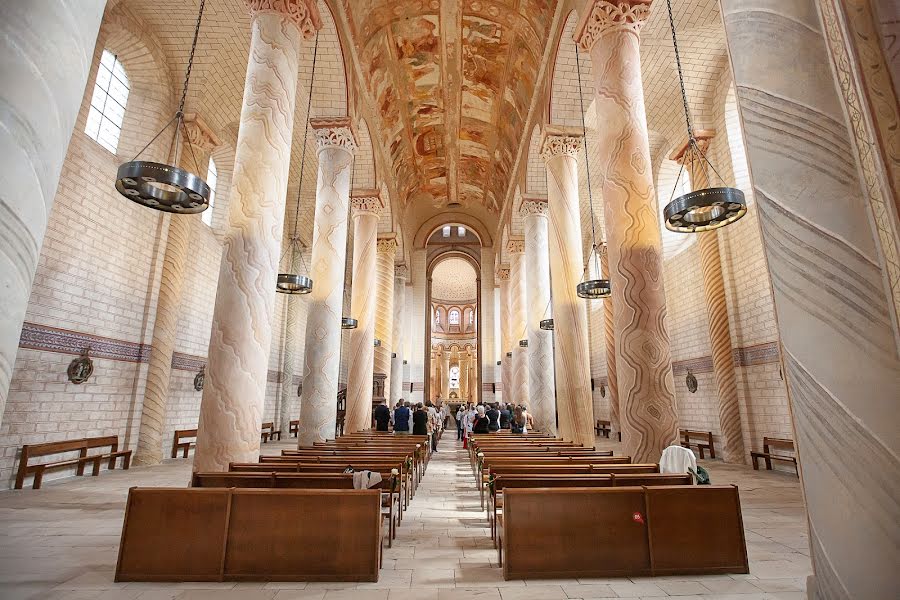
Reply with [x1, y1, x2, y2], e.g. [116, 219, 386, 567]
[0, 0, 106, 420]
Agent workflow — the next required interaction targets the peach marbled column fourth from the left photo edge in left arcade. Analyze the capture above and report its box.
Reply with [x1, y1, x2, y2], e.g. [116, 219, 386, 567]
[344, 190, 384, 433]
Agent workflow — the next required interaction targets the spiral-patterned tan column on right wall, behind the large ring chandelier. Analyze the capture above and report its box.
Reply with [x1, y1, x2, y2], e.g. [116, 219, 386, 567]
[669, 130, 747, 463]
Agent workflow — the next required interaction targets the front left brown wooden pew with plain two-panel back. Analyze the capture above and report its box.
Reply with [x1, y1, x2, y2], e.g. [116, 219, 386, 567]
[115, 488, 382, 582]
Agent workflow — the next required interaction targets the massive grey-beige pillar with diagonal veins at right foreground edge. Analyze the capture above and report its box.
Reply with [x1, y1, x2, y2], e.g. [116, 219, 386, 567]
[722, 0, 900, 598]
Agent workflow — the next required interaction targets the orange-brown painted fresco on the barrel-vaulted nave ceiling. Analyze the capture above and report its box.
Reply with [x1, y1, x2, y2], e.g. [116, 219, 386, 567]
[342, 0, 557, 236]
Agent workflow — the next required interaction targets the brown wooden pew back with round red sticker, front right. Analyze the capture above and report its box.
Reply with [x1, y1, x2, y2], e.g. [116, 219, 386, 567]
[497, 485, 749, 580]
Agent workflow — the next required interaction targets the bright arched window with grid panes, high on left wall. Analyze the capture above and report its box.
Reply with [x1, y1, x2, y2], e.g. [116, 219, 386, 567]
[84, 50, 131, 154]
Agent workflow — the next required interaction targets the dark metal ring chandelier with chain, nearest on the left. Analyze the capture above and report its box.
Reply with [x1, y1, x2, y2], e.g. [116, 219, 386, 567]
[116, 0, 211, 214]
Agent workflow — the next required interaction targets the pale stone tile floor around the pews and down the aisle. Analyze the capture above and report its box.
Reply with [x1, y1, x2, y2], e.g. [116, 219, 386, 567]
[0, 436, 810, 600]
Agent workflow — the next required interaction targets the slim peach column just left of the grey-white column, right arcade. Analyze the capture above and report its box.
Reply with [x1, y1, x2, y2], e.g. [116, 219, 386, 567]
[506, 237, 537, 414]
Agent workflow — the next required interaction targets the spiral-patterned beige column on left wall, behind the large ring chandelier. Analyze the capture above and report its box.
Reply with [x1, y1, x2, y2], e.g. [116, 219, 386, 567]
[134, 115, 219, 465]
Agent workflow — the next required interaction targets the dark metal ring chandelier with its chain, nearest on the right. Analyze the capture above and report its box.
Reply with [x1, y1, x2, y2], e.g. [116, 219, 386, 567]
[663, 0, 747, 233]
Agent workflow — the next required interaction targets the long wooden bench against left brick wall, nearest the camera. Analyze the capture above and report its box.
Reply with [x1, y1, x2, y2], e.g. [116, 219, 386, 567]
[15, 435, 131, 490]
